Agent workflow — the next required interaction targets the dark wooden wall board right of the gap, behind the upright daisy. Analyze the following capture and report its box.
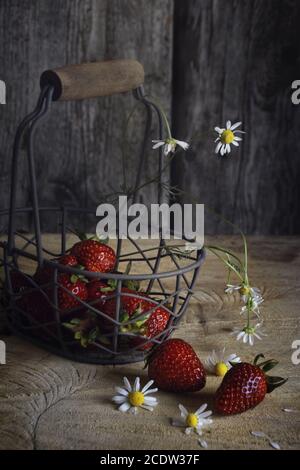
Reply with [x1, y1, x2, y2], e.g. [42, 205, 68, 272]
[172, 0, 300, 234]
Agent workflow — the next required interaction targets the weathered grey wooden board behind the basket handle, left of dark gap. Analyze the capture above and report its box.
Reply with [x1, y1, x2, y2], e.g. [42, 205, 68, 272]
[0, 0, 173, 230]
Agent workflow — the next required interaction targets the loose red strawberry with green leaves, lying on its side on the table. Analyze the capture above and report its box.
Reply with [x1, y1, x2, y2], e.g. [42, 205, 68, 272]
[215, 354, 287, 415]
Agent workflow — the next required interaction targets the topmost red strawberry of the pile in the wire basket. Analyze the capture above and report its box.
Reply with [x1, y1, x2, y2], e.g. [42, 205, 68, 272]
[71, 239, 116, 273]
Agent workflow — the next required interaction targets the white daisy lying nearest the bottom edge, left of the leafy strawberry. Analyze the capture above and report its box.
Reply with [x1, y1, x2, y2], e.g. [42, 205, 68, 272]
[172, 403, 213, 436]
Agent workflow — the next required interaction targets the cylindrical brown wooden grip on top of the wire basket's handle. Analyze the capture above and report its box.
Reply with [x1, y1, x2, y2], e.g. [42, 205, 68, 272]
[40, 59, 144, 101]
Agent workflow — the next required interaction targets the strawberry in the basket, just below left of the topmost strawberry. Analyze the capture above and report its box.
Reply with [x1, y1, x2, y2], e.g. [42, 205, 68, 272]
[58, 273, 88, 311]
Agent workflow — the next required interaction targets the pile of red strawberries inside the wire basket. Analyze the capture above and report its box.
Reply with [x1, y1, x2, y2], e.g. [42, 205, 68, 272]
[11, 238, 170, 349]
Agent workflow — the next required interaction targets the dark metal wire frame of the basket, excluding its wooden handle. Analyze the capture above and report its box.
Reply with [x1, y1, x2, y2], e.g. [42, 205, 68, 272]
[0, 85, 205, 364]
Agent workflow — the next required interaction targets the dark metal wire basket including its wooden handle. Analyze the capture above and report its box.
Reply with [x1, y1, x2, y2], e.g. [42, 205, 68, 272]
[0, 61, 204, 364]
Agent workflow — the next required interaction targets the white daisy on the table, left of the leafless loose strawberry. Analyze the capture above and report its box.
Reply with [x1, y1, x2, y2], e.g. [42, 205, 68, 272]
[112, 377, 158, 414]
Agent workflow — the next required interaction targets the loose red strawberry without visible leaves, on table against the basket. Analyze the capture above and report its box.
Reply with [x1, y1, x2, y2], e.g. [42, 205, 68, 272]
[148, 339, 206, 392]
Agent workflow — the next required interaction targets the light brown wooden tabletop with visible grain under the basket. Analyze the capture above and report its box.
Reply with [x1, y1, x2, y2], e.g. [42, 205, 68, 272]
[0, 237, 300, 450]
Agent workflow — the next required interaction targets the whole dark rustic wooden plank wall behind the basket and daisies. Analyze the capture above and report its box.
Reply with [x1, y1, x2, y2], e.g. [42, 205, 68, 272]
[0, 0, 300, 234]
